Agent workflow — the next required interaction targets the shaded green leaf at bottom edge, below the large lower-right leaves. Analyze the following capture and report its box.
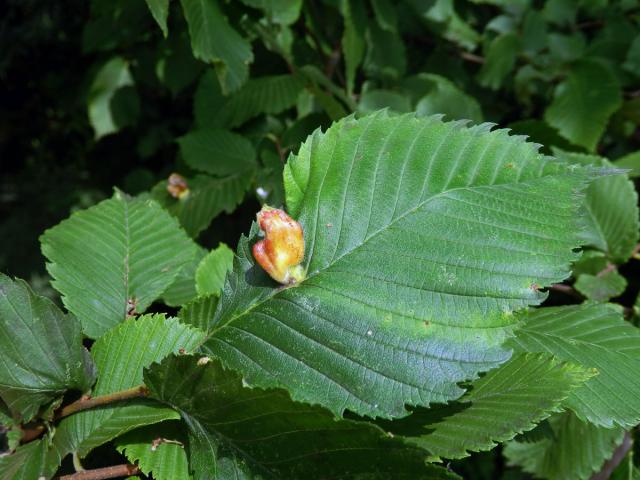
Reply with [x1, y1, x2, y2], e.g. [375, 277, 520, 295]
[504, 413, 624, 480]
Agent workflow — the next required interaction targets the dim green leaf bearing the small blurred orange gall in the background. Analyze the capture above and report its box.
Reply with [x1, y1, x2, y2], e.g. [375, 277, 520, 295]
[151, 172, 253, 237]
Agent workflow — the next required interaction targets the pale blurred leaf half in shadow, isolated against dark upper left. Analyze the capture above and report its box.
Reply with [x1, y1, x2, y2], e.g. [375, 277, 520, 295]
[87, 57, 139, 139]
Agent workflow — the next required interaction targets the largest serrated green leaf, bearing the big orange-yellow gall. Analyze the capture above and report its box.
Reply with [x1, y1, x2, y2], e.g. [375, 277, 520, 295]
[204, 112, 593, 417]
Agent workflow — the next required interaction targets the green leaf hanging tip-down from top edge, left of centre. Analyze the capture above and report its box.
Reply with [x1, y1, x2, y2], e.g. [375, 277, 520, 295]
[181, 0, 253, 95]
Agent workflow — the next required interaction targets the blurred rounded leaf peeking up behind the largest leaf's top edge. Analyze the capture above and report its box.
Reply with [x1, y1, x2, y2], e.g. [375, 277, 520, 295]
[416, 74, 482, 123]
